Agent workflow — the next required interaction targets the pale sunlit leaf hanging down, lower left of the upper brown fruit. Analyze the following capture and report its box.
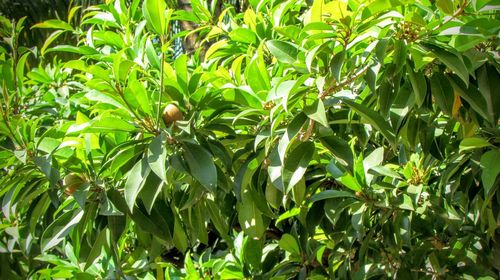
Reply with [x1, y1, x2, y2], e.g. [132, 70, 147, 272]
[124, 158, 151, 212]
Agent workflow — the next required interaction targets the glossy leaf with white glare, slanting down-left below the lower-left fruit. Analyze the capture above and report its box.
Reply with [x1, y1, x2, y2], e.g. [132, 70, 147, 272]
[41, 208, 84, 252]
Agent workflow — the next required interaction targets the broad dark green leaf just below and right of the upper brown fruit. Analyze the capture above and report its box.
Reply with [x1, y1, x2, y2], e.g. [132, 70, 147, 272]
[183, 142, 217, 192]
